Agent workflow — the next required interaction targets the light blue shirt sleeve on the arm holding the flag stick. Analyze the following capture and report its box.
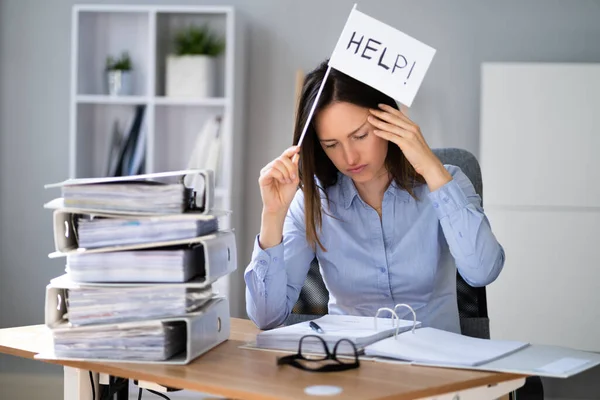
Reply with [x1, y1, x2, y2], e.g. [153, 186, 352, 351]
[244, 190, 315, 329]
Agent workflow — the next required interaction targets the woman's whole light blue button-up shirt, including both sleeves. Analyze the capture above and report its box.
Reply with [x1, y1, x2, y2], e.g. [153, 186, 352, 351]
[244, 165, 504, 333]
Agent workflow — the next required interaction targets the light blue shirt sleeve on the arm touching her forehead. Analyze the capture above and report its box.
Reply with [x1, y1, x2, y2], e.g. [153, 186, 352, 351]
[429, 165, 505, 286]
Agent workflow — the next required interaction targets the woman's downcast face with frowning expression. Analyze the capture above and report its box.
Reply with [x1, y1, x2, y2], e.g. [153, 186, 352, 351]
[315, 103, 389, 183]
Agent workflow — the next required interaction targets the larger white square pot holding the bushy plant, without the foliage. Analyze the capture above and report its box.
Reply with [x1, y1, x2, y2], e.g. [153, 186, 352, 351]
[166, 55, 216, 97]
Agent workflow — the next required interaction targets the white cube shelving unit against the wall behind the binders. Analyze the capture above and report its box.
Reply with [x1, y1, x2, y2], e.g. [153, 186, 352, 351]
[69, 5, 246, 310]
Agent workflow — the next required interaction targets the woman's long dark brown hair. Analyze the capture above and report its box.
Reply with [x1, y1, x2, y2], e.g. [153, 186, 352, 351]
[294, 61, 424, 251]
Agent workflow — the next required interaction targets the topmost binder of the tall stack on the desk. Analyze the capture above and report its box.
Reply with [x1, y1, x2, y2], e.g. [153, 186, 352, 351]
[44, 169, 215, 215]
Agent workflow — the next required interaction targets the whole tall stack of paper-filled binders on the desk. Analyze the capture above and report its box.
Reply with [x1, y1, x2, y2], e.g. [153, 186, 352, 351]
[38, 170, 237, 364]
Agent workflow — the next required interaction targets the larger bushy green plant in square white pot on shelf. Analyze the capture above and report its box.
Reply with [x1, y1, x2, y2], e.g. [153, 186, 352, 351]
[166, 25, 225, 97]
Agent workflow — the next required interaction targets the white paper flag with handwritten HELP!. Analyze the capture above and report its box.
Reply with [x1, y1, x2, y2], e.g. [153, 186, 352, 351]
[329, 8, 435, 107]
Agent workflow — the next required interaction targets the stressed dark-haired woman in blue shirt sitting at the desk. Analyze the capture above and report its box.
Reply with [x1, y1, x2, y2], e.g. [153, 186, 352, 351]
[244, 63, 504, 333]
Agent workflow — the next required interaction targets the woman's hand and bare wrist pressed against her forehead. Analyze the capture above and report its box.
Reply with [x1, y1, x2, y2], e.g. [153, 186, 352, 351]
[368, 104, 452, 191]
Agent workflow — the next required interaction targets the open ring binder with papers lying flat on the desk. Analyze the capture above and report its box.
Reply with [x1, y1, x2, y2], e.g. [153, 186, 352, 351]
[250, 304, 600, 378]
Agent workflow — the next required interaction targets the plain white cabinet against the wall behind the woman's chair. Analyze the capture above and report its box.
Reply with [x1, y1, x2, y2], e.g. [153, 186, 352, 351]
[480, 63, 600, 351]
